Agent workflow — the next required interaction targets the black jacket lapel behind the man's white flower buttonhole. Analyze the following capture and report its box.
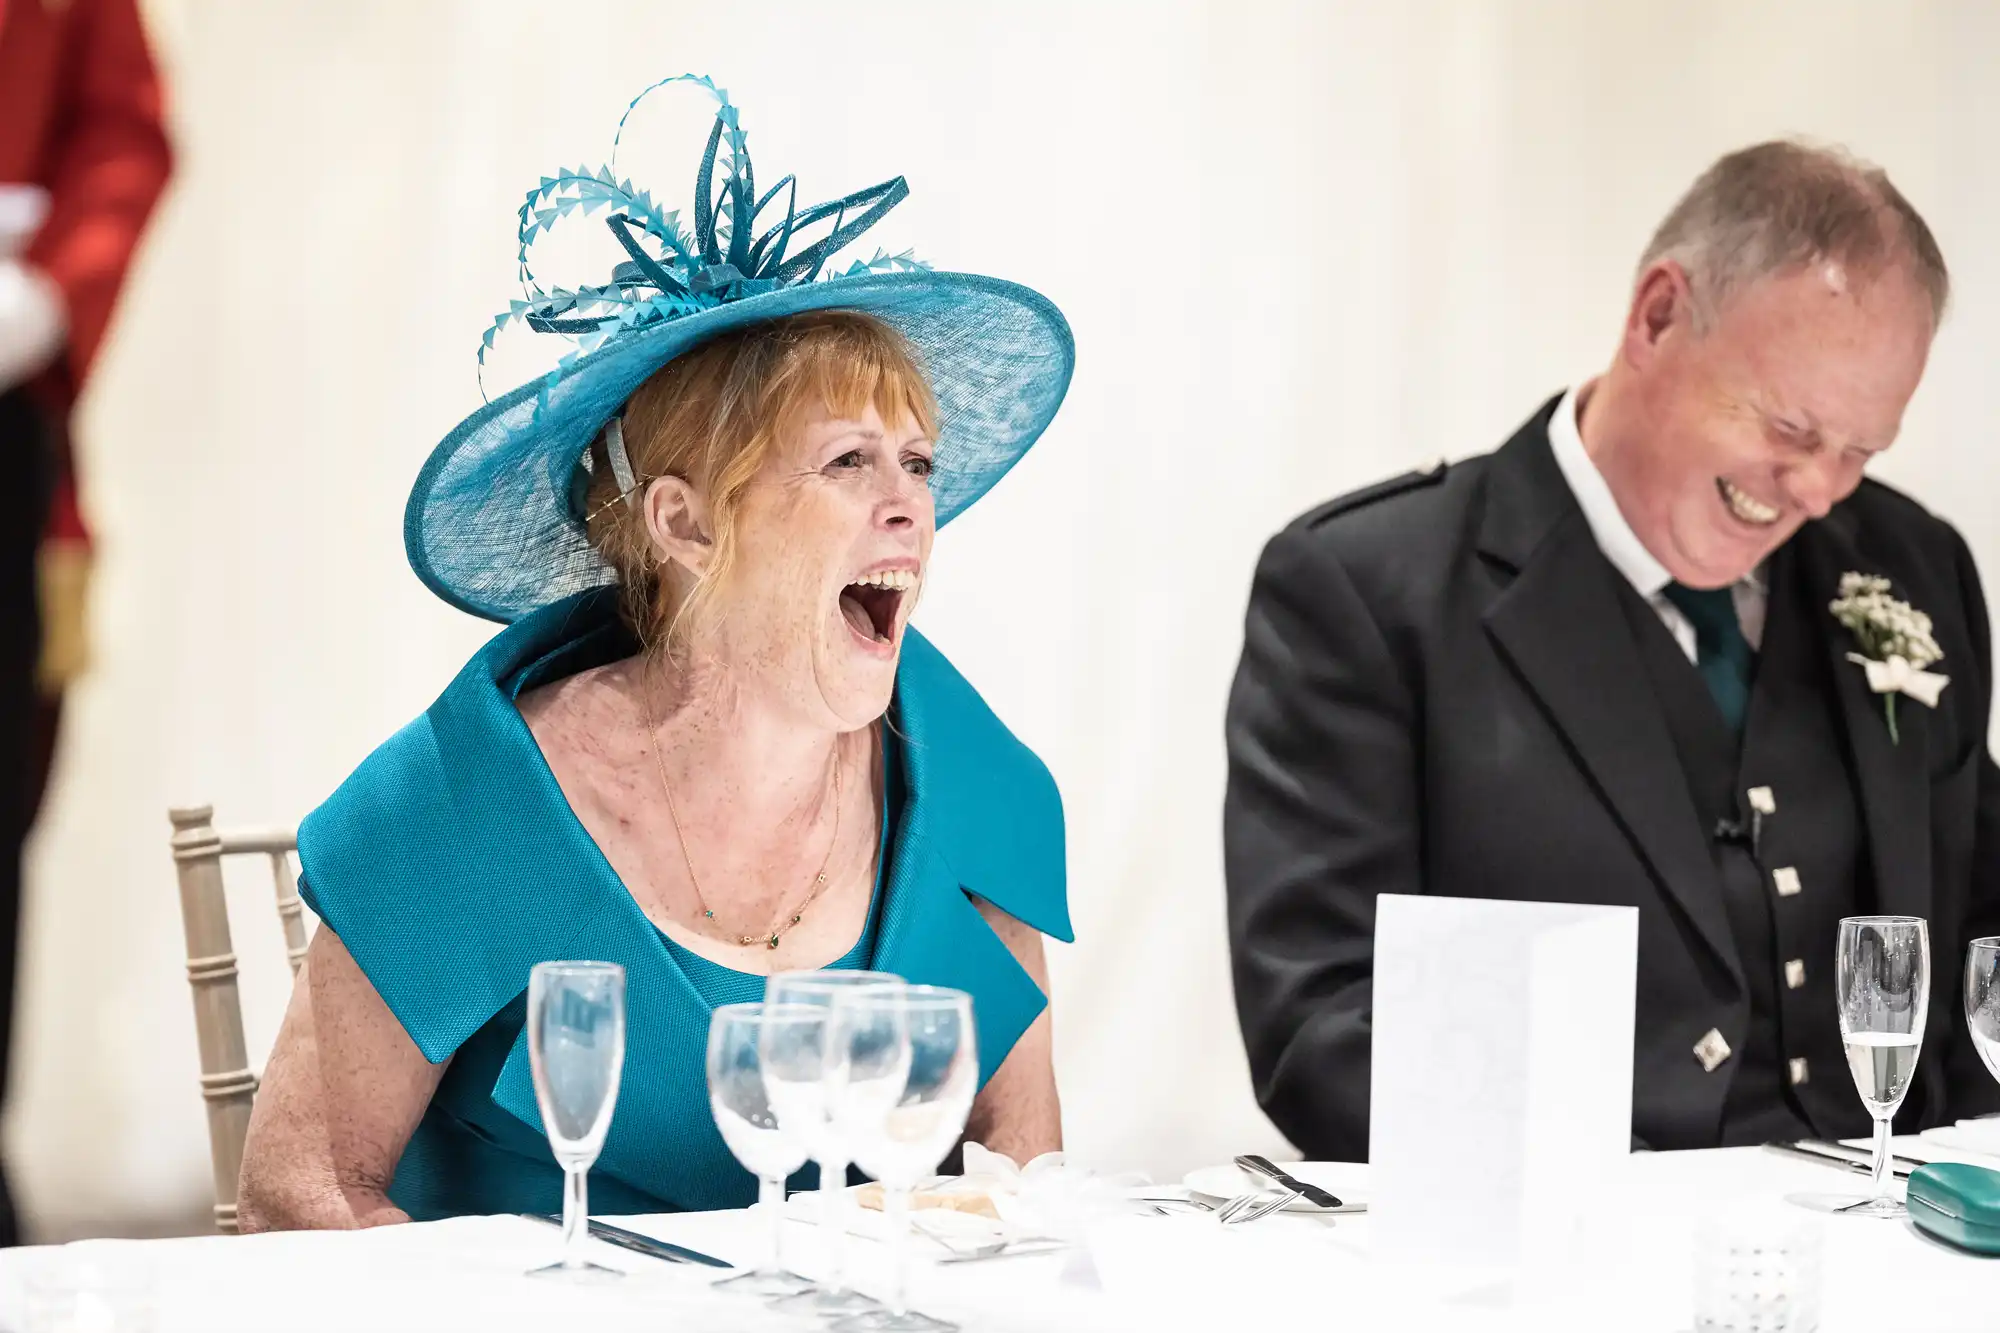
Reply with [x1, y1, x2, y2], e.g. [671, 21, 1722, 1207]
[1792, 508, 1930, 917]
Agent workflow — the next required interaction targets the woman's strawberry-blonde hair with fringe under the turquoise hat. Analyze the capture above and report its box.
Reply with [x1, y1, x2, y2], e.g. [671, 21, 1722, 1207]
[584, 310, 938, 648]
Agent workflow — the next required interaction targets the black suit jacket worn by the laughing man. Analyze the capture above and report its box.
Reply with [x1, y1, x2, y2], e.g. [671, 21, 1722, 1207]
[1224, 402, 2000, 1161]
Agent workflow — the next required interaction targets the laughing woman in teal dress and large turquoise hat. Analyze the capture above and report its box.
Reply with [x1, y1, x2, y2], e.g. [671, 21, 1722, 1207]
[240, 78, 1074, 1229]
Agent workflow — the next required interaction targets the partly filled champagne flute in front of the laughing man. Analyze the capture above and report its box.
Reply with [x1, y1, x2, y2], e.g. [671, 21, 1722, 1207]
[1834, 917, 1930, 1217]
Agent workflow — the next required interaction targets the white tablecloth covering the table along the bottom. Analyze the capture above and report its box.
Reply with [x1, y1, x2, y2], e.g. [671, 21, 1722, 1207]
[0, 1149, 2000, 1333]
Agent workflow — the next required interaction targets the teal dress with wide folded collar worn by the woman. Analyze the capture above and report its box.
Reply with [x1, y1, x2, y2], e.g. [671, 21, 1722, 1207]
[298, 588, 1070, 1219]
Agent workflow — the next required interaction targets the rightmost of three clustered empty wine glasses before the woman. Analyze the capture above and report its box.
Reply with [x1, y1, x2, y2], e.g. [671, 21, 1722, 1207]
[834, 987, 980, 1333]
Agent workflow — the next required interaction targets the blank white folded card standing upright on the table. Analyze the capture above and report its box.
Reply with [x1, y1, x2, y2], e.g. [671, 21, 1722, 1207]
[1368, 895, 1638, 1271]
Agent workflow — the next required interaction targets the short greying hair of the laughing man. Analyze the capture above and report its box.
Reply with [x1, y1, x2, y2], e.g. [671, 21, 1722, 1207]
[1640, 140, 1952, 328]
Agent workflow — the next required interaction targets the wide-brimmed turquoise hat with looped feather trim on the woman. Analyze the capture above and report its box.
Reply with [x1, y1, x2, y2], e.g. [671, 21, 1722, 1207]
[404, 74, 1076, 622]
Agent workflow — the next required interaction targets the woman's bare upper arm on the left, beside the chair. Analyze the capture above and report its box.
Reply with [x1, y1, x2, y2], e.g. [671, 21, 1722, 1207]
[238, 927, 444, 1231]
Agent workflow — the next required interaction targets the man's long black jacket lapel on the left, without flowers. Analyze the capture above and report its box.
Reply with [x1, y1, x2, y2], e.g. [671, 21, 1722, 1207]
[1480, 408, 1742, 985]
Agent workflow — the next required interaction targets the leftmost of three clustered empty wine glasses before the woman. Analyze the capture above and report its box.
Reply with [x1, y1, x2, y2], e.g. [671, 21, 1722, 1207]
[708, 1005, 826, 1297]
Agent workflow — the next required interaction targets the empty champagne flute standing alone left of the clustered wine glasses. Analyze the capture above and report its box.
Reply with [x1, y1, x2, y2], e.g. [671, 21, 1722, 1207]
[528, 963, 624, 1283]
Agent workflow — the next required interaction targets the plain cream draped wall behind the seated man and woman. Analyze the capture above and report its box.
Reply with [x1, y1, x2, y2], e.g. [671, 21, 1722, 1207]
[6, 0, 2000, 1233]
